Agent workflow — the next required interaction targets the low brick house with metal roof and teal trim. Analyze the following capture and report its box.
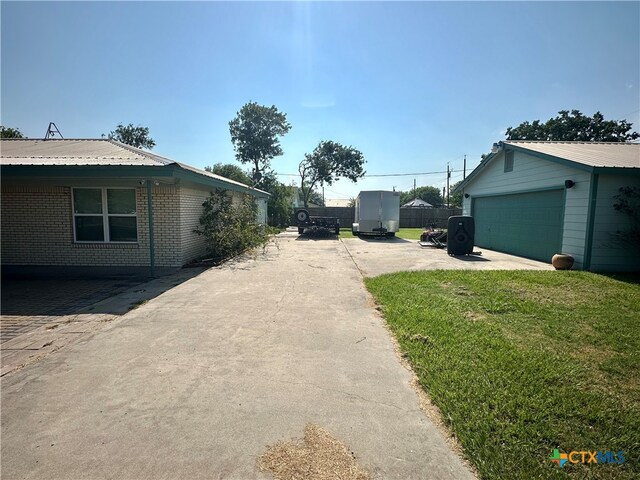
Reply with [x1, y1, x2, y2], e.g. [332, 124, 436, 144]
[0, 139, 269, 274]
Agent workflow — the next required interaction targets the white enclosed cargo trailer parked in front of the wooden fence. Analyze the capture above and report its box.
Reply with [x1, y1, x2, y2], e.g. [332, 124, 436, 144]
[351, 190, 400, 237]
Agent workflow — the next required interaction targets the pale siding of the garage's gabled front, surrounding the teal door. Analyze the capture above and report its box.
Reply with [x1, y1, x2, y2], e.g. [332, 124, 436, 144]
[463, 152, 591, 268]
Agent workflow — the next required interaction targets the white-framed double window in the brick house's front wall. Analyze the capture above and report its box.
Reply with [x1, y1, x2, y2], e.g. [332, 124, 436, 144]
[73, 188, 138, 242]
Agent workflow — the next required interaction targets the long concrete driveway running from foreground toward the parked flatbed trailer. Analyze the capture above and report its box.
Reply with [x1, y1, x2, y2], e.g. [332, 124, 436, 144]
[1, 233, 473, 480]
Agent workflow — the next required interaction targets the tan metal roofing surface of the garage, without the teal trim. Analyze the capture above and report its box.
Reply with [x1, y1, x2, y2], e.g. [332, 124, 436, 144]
[503, 140, 640, 168]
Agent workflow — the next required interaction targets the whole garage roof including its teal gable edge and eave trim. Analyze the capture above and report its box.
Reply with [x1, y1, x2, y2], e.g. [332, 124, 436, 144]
[453, 140, 640, 192]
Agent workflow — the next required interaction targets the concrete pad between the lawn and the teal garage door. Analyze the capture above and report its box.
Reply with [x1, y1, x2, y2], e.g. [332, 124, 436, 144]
[342, 237, 553, 277]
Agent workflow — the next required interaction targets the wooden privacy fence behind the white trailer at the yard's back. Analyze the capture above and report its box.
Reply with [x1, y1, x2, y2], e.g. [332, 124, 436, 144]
[291, 207, 462, 228]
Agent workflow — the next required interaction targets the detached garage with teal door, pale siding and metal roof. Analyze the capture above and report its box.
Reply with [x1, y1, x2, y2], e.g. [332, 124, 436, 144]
[456, 141, 640, 272]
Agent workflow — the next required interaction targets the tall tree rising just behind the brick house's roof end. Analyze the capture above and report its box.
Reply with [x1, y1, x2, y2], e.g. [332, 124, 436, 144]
[229, 102, 291, 183]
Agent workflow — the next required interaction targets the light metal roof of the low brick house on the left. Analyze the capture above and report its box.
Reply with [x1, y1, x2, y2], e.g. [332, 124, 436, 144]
[0, 138, 268, 195]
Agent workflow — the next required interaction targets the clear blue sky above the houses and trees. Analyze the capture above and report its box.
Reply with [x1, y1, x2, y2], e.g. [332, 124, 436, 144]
[1, 1, 640, 198]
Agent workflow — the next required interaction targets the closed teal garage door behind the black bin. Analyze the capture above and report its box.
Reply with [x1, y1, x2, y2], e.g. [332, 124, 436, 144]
[472, 190, 564, 262]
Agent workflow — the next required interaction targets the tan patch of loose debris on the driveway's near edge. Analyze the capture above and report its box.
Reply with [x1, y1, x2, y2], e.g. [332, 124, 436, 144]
[258, 423, 372, 480]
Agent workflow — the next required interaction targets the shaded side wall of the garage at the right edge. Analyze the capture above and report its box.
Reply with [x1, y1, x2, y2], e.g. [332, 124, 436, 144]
[591, 175, 640, 272]
